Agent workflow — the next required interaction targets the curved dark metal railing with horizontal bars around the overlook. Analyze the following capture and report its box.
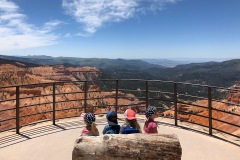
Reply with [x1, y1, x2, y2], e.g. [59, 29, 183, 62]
[0, 79, 240, 138]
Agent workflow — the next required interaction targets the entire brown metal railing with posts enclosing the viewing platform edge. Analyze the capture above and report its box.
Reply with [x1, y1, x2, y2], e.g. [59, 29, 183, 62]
[0, 79, 240, 138]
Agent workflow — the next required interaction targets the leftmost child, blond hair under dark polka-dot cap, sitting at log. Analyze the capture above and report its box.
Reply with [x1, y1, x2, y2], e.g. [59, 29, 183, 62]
[80, 113, 99, 136]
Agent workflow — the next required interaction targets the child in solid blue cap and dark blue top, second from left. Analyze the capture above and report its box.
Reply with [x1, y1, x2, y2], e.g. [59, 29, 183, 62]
[103, 110, 120, 134]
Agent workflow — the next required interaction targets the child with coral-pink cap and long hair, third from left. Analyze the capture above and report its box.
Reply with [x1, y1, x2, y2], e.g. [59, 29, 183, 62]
[120, 109, 142, 134]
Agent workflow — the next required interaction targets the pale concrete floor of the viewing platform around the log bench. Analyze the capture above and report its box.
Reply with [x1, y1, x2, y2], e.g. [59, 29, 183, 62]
[0, 114, 240, 160]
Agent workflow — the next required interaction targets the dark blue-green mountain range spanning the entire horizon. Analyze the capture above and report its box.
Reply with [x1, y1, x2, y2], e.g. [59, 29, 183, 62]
[0, 55, 240, 87]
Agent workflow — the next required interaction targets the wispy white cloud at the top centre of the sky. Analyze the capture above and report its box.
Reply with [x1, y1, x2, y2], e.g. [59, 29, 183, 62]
[62, 0, 138, 33]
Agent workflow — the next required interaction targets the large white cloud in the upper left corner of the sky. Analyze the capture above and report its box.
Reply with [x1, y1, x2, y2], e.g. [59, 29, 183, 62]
[0, 0, 61, 52]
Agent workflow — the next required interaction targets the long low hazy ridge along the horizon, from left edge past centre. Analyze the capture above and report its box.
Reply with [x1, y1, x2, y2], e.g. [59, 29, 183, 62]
[0, 55, 163, 70]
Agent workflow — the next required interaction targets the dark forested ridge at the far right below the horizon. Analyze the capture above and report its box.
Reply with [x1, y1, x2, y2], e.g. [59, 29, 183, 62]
[147, 59, 240, 87]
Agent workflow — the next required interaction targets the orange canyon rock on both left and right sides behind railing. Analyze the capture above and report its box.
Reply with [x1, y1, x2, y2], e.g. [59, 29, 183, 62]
[0, 62, 240, 136]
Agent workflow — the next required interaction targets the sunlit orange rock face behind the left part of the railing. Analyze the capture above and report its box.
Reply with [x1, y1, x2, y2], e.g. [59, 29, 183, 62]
[0, 64, 145, 131]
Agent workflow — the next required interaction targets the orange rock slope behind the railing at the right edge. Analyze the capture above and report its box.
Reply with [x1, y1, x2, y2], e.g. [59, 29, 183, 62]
[164, 83, 240, 136]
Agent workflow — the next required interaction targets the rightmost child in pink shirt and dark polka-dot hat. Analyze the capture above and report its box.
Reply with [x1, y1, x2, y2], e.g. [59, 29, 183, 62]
[143, 106, 158, 134]
